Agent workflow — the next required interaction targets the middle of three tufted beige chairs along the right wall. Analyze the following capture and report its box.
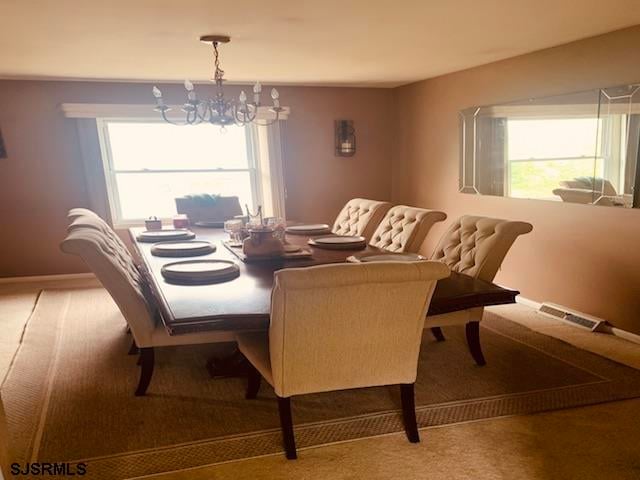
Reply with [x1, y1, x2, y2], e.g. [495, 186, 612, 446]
[369, 205, 447, 253]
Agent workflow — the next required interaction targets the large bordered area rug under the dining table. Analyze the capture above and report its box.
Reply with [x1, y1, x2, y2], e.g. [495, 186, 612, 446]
[2, 288, 640, 479]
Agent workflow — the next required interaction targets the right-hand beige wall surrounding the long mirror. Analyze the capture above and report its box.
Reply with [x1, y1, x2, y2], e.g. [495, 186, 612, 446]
[392, 27, 640, 333]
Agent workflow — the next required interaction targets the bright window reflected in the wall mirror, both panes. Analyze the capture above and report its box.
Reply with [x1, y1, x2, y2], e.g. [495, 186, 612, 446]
[505, 118, 605, 200]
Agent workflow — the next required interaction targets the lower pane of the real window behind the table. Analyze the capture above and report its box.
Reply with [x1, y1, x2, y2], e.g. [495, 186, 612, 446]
[116, 172, 253, 219]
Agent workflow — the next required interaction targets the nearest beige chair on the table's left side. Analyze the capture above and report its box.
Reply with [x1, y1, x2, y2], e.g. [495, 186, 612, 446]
[60, 209, 234, 396]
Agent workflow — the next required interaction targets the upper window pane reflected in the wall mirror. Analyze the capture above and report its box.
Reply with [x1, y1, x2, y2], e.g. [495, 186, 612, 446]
[507, 118, 598, 160]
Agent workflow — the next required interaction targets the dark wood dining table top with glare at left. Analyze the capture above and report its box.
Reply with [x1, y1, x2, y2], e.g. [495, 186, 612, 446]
[129, 227, 519, 335]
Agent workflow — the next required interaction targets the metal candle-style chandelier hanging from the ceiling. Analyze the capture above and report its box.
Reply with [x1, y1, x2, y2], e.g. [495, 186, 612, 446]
[153, 35, 284, 128]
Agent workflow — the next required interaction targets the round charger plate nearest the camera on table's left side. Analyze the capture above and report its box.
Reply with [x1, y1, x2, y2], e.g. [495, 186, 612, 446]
[160, 260, 240, 285]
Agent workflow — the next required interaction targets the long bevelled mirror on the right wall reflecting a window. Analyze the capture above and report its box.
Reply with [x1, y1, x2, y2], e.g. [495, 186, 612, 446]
[460, 84, 640, 208]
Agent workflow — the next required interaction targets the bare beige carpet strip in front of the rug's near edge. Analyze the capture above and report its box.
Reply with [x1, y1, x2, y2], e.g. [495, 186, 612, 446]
[144, 400, 640, 480]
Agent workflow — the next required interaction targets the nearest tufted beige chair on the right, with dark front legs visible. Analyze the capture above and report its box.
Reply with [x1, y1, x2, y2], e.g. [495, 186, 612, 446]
[425, 215, 533, 365]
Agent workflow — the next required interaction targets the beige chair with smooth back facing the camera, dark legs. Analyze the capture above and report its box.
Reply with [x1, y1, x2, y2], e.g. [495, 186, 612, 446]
[237, 262, 449, 459]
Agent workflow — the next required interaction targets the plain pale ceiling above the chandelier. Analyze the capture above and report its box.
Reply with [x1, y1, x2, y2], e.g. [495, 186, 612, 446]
[0, 0, 640, 86]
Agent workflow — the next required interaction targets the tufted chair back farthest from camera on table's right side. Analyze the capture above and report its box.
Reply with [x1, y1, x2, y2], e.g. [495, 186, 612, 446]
[331, 198, 391, 241]
